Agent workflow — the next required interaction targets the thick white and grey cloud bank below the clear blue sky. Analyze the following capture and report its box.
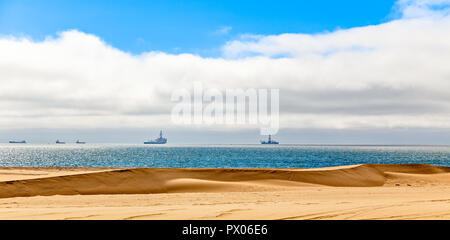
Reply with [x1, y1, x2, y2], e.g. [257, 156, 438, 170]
[0, 0, 450, 129]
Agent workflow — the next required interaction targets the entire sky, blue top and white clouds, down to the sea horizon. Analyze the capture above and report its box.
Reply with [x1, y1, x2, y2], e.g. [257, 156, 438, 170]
[0, 0, 450, 144]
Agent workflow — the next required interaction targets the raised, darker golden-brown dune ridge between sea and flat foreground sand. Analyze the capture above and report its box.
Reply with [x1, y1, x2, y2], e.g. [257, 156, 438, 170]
[0, 164, 450, 198]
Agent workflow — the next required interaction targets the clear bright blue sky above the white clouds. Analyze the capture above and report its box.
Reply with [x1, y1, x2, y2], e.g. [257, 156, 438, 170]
[0, 0, 395, 56]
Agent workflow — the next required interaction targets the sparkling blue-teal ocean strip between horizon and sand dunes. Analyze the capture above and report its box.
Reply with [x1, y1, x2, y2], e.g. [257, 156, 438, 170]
[0, 143, 450, 168]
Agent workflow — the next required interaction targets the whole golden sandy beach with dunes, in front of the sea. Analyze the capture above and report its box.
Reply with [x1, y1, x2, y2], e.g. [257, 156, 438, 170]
[0, 164, 450, 220]
